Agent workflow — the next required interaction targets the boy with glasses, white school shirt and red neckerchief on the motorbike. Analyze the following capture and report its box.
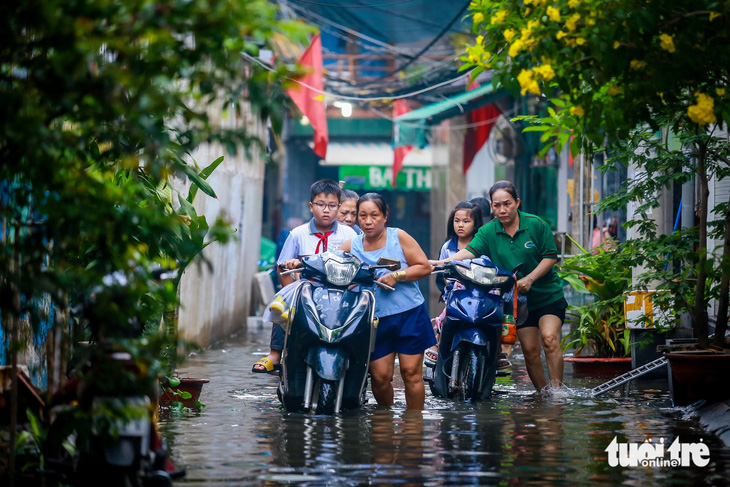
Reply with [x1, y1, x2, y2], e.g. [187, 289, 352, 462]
[251, 179, 357, 373]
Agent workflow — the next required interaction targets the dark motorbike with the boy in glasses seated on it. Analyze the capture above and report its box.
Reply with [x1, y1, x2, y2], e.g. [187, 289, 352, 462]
[278, 251, 400, 414]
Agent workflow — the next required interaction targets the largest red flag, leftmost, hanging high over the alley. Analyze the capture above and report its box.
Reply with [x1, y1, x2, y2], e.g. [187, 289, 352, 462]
[286, 34, 329, 159]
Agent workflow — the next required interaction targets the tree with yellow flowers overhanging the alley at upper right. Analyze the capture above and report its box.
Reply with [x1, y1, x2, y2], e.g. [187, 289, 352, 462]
[463, 0, 730, 350]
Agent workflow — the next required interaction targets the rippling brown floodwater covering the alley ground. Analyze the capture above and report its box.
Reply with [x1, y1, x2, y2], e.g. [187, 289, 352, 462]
[161, 326, 730, 487]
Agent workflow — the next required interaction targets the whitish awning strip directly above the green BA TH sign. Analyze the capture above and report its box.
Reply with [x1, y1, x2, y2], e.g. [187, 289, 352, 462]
[320, 142, 432, 167]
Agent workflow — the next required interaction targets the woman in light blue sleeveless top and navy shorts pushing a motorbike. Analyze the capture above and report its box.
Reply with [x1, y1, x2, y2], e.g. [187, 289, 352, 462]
[340, 193, 436, 409]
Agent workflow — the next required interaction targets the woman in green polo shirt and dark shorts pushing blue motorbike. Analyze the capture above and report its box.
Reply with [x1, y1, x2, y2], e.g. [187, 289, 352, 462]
[436, 181, 568, 391]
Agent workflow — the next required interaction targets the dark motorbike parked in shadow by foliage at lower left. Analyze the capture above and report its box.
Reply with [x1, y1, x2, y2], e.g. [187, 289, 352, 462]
[44, 271, 185, 487]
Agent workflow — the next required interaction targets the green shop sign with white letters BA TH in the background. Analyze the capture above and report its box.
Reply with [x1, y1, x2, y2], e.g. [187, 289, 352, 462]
[340, 166, 431, 191]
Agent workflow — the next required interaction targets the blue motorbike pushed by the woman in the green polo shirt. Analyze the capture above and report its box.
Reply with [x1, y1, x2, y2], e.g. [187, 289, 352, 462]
[424, 256, 517, 400]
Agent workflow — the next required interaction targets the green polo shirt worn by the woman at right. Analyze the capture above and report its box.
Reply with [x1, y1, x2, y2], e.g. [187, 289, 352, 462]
[466, 211, 563, 310]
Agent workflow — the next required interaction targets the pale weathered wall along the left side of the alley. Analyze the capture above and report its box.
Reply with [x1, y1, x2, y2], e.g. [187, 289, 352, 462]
[178, 102, 266, 346]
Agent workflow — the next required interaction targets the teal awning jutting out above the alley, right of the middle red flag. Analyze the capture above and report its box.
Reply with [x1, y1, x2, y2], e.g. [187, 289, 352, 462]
[394, 83, 507, 147]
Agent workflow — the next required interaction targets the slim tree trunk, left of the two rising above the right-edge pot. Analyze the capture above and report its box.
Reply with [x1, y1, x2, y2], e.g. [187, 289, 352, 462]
[692, 143, 710, 348]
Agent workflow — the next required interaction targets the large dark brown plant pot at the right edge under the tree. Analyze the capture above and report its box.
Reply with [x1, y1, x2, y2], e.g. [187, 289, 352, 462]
[664, 350, 730, 406]
